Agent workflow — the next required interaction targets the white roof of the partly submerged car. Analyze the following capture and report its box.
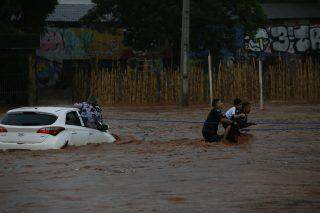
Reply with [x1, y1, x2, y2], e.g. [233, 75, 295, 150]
[8, 107, 78, 114]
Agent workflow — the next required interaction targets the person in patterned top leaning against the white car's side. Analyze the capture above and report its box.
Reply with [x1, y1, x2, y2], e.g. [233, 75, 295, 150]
[74, 96, 103, 129]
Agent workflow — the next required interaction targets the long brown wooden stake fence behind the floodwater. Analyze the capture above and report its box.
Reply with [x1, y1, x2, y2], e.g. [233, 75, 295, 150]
[73, 59, 320, 105]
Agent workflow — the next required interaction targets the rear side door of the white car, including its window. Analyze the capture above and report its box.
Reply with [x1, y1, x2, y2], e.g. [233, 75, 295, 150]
[66, 111, 89, 146]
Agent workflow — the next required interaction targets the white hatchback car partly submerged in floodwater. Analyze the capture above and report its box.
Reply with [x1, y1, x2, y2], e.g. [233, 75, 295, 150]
[0, 107, 115, 150]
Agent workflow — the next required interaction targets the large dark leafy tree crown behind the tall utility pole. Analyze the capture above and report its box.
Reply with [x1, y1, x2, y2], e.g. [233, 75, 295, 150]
[83, 0, 266, 55]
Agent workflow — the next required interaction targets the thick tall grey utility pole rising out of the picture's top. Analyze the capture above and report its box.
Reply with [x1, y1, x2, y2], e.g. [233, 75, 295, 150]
[180, 0, 190, 106]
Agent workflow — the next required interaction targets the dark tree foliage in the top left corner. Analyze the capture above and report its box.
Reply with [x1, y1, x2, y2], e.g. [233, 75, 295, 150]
[0, 0, 58, 34]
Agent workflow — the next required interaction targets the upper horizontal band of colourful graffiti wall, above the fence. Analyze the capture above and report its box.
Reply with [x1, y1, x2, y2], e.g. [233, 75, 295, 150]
[37, 28, 123, 62]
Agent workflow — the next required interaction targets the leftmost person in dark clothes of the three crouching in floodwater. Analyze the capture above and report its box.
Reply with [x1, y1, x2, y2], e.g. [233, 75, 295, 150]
[202, 99, 232, 142]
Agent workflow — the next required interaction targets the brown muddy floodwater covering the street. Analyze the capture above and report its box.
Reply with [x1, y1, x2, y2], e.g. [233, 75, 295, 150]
[0, 105, 320, 212]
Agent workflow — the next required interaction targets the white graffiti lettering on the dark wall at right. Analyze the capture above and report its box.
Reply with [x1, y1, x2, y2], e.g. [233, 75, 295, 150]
[245, 26, 320, 53]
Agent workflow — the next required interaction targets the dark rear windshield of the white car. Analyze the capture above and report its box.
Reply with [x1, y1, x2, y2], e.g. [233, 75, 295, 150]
[1, 112, 58, 126]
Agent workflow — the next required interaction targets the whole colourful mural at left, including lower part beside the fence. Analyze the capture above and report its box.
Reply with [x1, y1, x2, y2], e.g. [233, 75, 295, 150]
[37, 27, 125, 86]
